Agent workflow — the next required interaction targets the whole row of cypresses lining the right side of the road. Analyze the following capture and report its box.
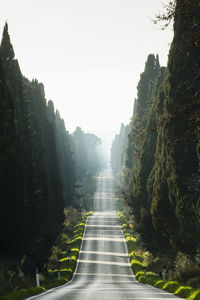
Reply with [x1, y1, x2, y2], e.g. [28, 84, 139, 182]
[111, 0, 200, 257]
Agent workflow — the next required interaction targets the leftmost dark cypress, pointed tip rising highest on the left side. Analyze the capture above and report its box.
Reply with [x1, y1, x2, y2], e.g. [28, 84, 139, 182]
[0, 24, 29, 254]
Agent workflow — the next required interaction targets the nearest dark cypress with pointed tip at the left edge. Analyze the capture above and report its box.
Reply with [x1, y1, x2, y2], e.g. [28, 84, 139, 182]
[0, 23, 27, 255]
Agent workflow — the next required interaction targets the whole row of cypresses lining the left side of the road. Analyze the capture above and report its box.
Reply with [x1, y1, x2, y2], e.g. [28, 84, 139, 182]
[0, 23, 104, 268]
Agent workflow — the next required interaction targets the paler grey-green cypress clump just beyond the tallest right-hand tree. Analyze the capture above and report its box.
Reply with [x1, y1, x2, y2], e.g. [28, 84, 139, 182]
[122, 54, 168, 251]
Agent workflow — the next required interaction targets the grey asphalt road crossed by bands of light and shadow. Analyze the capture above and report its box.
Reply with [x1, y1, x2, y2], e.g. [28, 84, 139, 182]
[29, 171, 181, 300]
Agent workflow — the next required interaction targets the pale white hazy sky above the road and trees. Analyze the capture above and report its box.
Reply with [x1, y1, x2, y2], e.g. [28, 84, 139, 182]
[0, 0, 172, 145]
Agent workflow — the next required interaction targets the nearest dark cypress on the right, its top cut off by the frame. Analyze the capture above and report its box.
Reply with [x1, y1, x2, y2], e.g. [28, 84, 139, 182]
[152, 0, 200, 255]
